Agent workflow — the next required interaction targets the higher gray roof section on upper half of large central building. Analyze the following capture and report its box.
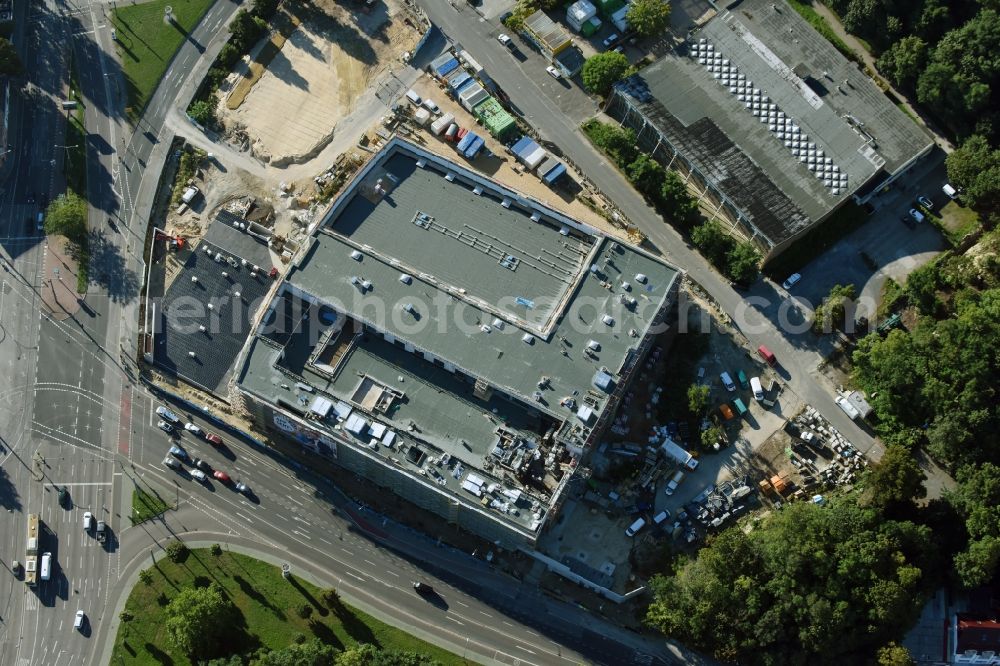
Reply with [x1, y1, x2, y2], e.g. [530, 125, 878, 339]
[287, 144, 678, 417]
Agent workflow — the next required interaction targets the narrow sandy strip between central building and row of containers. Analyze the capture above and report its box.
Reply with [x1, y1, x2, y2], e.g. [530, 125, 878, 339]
[403, 75, 627, 240]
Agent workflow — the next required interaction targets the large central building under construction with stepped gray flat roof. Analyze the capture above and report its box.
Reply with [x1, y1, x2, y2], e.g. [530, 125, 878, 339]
[235, 137, 681, 548]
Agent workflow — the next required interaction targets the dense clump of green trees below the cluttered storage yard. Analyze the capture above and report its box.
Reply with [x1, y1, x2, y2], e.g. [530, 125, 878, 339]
[646, 494, 935, 664]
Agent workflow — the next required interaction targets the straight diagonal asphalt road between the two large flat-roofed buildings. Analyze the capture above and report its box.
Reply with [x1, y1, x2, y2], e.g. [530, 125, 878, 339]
[418, 0, 882, 460]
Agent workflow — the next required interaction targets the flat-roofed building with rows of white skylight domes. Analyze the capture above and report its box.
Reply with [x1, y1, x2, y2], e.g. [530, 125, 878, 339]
[606, 0, 933, 257]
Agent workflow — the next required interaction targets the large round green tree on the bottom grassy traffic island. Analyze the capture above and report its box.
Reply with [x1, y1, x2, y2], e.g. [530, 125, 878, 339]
[164, 583, 238, 659]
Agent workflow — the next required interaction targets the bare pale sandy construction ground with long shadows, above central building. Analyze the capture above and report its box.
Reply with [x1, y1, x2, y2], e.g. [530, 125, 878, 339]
[217, 0, 420, 165]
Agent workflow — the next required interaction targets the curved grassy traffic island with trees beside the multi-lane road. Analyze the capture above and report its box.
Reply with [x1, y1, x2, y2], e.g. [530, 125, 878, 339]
[110, 546, 472, 666]
